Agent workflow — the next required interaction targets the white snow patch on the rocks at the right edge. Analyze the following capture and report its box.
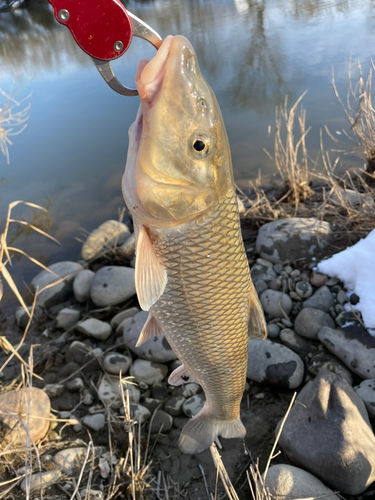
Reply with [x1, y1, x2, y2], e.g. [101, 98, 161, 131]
[317, 229, 375, 336]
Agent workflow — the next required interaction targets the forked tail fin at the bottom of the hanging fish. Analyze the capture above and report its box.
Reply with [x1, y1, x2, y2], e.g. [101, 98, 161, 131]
[178, 409, 246, 454]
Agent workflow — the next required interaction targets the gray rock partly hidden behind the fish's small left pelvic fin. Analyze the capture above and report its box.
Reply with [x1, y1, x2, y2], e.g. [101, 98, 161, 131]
[121, 311, 177, 363]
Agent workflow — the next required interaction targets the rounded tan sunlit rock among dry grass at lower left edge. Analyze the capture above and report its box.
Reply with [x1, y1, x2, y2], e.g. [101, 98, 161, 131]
[0, 387, 51, 448]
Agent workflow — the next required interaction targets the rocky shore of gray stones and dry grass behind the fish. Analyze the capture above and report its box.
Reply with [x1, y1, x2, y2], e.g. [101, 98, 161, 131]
[0, 212, 375, 500]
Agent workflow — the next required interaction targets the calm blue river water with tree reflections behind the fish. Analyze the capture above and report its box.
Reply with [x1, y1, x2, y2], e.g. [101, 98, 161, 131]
[0, 0, 375, 309]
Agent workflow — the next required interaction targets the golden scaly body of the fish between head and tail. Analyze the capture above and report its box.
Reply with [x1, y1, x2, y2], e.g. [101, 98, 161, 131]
[150, 190, 253, 421]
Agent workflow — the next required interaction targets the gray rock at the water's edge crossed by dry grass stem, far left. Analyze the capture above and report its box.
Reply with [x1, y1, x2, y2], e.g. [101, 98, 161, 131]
[31, 261, 83, 308]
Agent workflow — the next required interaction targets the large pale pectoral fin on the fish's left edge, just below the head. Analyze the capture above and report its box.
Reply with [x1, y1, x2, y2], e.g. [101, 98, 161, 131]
[135, 226, 167, 311]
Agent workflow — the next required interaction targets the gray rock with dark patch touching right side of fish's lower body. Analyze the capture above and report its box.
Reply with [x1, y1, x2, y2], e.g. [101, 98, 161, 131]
[247, 338, 304, 389]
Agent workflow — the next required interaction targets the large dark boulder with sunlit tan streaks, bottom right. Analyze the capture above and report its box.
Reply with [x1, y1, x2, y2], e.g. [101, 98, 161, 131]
[277, 372, 375, 495]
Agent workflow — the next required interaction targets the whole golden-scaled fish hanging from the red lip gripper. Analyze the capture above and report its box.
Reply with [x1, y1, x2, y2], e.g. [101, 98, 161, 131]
[122, 35, 266, 453]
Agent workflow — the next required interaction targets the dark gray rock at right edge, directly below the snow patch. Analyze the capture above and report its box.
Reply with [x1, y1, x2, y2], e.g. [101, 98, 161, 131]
[318, 325, 375, 379]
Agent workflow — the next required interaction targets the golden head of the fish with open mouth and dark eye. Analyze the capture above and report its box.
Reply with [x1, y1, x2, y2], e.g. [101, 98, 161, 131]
[123, 36, 233, 226]
